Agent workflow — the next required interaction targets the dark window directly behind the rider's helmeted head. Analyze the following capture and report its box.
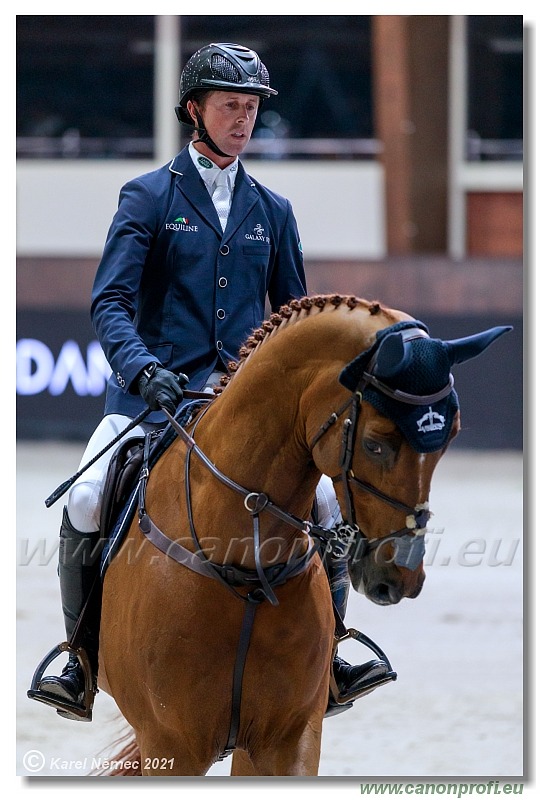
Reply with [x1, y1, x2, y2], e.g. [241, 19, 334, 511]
[182, 15, 377, 157]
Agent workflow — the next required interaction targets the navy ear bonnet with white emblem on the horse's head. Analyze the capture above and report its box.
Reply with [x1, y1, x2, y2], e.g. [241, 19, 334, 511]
[339, 320, 512, 453]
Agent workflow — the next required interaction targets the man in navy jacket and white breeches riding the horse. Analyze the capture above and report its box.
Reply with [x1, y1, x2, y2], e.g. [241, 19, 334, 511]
[32, 44, 386, 719]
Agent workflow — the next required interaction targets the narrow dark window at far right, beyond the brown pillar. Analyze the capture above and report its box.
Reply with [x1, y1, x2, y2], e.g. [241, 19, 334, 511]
[467, 15, 523, 161]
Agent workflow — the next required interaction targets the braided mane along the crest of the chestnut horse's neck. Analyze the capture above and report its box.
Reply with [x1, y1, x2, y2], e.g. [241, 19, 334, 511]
[214, 294, 384, 394]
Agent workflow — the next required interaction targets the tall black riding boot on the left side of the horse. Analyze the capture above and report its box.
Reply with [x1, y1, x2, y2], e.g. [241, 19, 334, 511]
[39, 508, 101, 719]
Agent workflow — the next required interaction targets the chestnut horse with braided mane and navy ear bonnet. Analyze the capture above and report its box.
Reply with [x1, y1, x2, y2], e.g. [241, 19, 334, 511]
[90, 295, 508, 776]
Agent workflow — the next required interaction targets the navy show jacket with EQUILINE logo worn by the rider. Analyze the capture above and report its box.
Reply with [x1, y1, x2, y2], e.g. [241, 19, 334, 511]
[91, 147, 306, 421]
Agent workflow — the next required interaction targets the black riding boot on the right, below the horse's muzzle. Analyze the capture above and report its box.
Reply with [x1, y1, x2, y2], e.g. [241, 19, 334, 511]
[324, 555, 388, 717]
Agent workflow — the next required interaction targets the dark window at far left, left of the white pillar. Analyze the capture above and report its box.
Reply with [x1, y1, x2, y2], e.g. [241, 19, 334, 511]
[17, 15, 154, 158]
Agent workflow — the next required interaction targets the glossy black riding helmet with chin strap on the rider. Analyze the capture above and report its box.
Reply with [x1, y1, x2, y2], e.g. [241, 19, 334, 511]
[175, 43, 277, 156]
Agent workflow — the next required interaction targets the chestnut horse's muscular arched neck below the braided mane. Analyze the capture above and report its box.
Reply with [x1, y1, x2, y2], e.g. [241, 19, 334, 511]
[186, 309, 400, 564]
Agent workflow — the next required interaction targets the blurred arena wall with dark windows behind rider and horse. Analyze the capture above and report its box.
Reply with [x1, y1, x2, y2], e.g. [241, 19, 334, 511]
[17, 15, 527, 448]
